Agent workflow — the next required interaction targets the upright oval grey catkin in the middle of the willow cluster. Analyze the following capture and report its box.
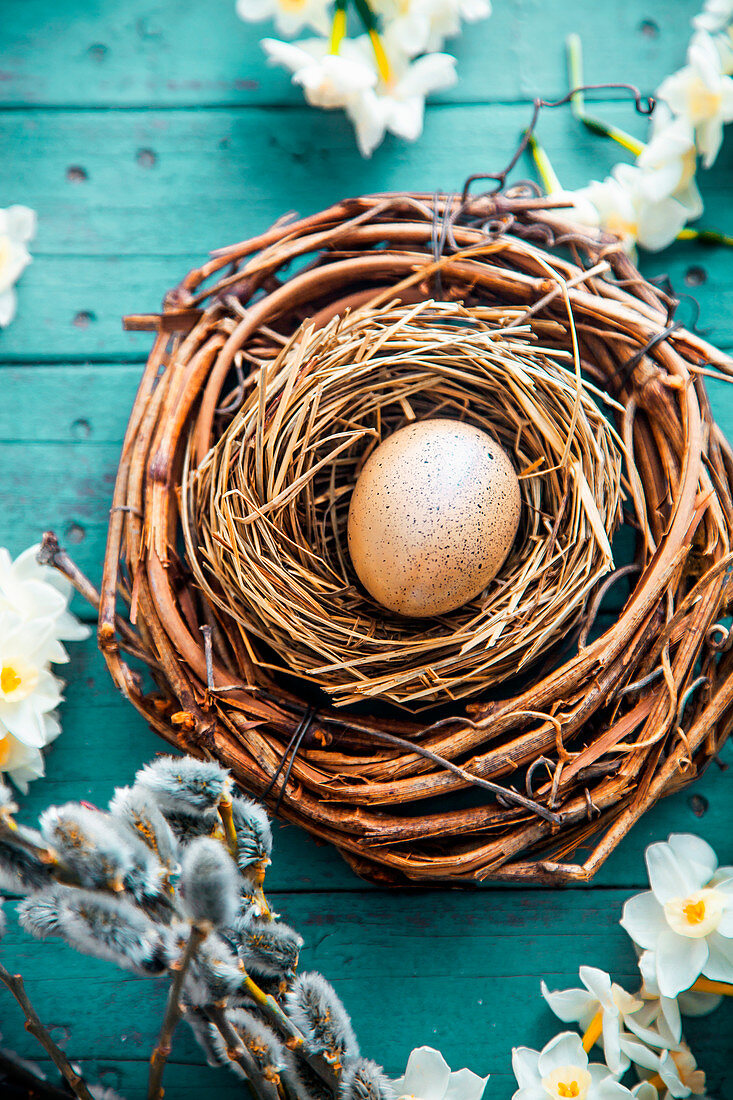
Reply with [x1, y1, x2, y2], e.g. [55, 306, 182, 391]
[180, 837, 241, 928]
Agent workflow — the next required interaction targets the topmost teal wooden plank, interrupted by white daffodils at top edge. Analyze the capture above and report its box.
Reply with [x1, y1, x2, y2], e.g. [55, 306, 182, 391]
[0, 0, 699, 107]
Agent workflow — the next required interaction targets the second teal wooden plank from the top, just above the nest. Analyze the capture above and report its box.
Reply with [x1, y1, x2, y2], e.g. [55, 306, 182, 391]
[0, 103, 669, 257]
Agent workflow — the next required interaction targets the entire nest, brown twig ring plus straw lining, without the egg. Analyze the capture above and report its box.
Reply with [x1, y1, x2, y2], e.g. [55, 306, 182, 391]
[99, 189, 733, 882]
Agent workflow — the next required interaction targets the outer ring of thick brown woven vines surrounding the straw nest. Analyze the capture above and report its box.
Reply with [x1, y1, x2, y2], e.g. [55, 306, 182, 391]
[99, 190, 733, 883]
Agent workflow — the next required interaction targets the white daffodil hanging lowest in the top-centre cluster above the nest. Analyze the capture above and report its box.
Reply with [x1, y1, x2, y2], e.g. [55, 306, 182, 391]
[346, 35, 457, 156]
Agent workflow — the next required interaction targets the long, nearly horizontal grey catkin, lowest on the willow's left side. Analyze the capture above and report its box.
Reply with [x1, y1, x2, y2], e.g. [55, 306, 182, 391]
[18, 886, 172, 975]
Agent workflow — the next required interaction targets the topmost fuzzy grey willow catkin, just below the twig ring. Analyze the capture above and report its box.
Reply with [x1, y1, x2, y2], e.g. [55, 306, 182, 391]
[135, 757, 231, 817]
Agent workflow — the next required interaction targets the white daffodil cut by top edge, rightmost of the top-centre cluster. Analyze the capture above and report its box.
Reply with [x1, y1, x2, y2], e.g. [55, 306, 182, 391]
[382, 0, 491, 57]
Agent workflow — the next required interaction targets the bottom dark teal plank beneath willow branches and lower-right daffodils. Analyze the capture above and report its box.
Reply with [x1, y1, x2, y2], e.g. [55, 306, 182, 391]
[0, 890, 733, 1100]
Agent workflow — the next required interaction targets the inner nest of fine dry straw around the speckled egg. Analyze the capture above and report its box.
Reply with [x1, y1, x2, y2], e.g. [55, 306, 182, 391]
[182, 300, 623, 708]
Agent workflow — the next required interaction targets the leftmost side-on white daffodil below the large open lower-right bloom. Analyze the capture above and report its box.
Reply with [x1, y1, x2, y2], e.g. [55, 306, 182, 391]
[540, 966, 644, 1075]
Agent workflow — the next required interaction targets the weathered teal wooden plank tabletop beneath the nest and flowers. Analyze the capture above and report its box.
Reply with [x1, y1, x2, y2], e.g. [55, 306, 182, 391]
[0, 0, 733, 1100]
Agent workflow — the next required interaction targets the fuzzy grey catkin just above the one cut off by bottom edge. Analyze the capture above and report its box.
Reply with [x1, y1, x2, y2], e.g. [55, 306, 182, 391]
[286, 971, 359, 1067]
